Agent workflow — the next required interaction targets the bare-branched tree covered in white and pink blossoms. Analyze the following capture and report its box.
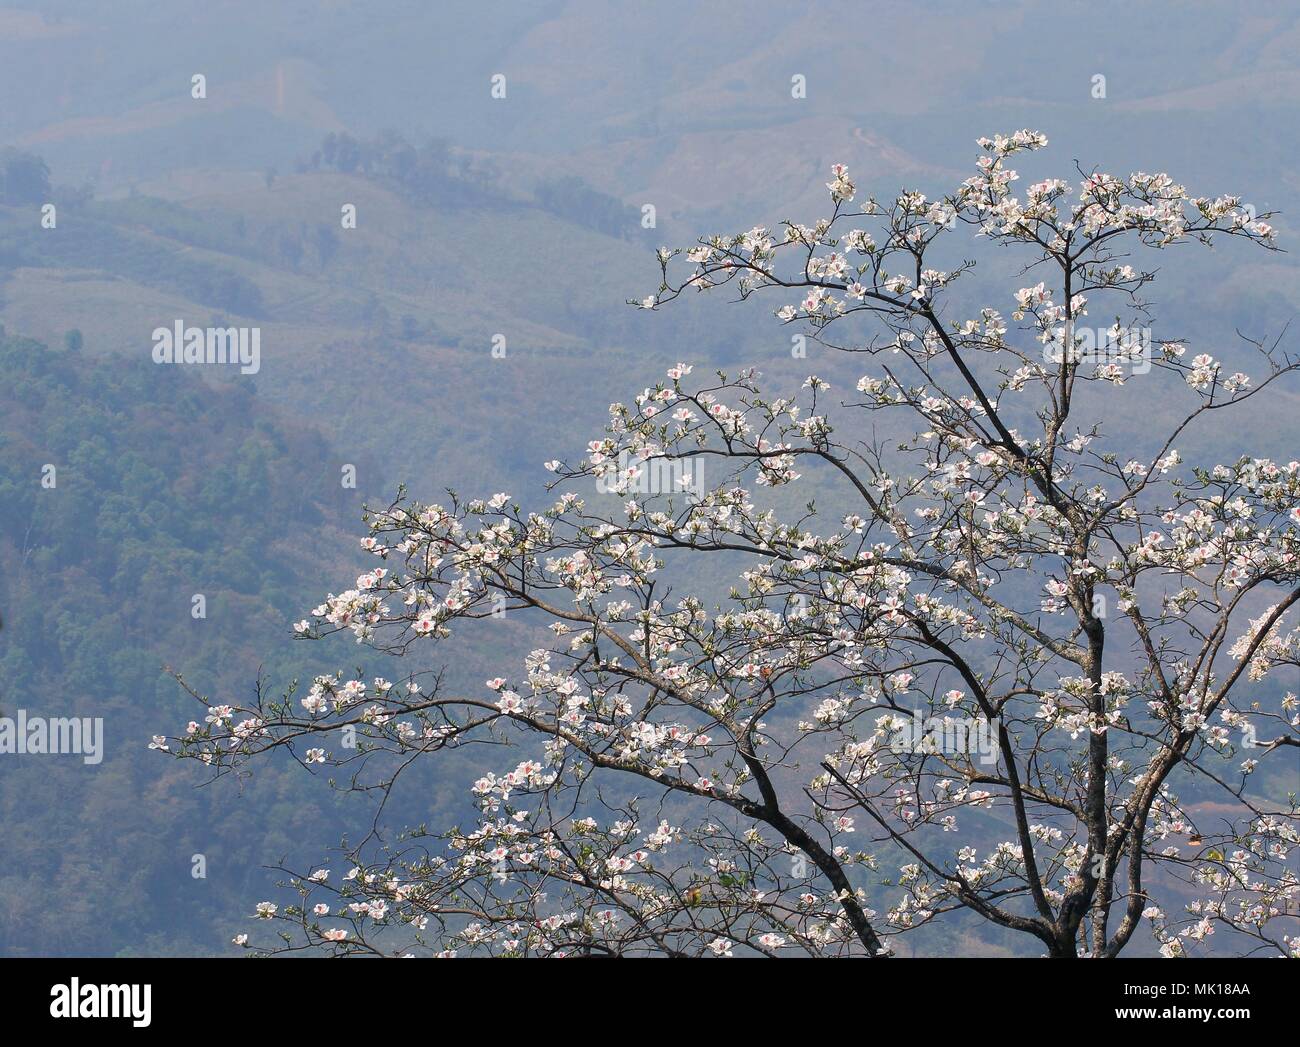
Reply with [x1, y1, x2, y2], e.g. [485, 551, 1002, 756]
[155, 131, 1300, 956]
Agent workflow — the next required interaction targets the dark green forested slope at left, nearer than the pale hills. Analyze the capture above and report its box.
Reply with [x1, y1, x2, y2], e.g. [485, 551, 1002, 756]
[0, 330, 379, 953]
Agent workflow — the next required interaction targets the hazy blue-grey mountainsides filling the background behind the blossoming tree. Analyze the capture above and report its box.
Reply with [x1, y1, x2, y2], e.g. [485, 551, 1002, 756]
[0, 0, 1300, 953]
